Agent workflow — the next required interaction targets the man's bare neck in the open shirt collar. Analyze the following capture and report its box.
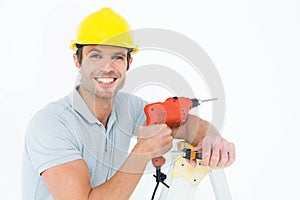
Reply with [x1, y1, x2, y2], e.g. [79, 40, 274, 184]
[78, 87, 114, 127]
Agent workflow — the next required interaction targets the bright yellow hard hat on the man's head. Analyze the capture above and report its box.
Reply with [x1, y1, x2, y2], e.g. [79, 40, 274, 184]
[70, 8, 137, 53]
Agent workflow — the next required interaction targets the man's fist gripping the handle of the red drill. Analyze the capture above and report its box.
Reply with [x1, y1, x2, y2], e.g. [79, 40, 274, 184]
[132, 124, 173, 159]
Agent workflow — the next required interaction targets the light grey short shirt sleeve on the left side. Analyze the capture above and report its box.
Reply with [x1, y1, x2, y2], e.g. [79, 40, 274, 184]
[25, 112, 82, 174]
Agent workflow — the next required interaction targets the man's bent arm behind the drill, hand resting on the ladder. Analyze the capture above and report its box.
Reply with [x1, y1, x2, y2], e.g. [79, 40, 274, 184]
[173, 115, 235, 167]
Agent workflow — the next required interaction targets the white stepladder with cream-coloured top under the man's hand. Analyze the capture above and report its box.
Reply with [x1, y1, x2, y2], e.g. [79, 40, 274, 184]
[159, 142, 232, 200]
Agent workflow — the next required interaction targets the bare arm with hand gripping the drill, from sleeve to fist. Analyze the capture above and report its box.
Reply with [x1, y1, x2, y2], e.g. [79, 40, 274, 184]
[42, 125, 172, 200]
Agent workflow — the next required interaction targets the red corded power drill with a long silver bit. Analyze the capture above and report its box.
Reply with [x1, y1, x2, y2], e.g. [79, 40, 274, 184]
[144, 97, 217, 199]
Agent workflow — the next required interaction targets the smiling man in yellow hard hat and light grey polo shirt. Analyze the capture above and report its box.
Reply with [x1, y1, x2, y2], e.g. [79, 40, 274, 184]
[23, 8, 235, 200]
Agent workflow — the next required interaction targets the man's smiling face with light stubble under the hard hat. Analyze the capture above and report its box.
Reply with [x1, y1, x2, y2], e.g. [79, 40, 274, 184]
[79, 45, 127, 99]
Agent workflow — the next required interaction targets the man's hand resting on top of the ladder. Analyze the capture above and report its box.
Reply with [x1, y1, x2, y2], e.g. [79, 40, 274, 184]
[193, 134, 235, 167]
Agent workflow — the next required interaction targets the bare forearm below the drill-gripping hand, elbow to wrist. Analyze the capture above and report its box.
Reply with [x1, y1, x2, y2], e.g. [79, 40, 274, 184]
[88, 146, 150, 200]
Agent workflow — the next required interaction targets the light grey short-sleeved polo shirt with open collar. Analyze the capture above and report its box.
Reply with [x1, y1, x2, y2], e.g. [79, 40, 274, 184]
[22, 89, 147, 200]
